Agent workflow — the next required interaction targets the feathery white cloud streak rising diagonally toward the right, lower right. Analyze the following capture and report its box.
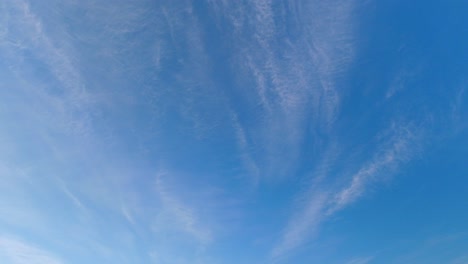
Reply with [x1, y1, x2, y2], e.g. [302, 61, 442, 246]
[271, 124, 421, 259]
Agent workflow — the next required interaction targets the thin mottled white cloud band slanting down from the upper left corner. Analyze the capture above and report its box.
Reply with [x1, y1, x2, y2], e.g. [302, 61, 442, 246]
[1, 0, 93, 139]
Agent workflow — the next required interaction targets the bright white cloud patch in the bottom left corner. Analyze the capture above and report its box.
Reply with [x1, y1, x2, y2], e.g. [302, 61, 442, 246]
[0, 237, 64, 264]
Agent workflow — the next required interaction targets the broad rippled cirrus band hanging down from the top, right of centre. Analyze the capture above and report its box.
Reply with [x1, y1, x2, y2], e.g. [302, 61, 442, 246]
[206, 1, 355, 182]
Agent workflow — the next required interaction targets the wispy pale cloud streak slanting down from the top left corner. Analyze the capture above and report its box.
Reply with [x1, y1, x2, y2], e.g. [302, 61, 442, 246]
[4, 0, 92, 135]
